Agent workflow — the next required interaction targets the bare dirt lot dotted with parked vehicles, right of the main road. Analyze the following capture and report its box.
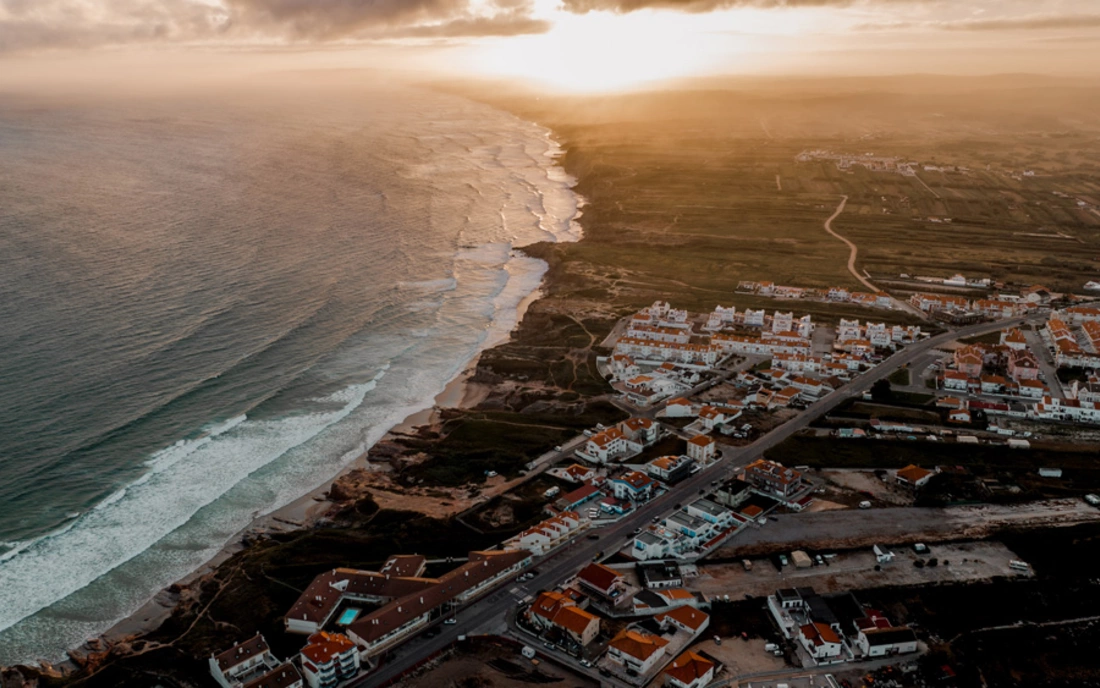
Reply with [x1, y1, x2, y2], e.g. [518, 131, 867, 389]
[686, 542, 1030, 599]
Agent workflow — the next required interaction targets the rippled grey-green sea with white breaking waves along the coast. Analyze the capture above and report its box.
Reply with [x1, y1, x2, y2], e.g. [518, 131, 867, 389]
[0, 85, 579, 664]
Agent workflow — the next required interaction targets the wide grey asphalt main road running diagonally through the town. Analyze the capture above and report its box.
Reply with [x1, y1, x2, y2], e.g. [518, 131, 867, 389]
[350, 316, 1040, 687]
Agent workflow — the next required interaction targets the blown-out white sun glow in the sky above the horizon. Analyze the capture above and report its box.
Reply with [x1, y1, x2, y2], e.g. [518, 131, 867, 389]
[475, 12, 729, 92]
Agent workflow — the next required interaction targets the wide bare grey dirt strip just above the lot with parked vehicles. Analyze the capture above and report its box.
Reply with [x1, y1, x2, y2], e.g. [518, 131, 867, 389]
[713, 500, 1100, 558]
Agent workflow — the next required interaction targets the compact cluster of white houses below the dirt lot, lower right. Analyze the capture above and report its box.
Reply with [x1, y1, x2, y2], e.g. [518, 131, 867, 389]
[768, 585, 917, 666]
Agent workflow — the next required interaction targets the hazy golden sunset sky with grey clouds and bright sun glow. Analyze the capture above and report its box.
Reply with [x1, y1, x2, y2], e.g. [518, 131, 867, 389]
[0, 0, 1100, 89]
